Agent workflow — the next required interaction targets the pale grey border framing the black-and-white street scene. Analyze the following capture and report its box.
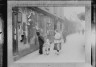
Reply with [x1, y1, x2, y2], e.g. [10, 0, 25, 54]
[7, 1, 91, 67]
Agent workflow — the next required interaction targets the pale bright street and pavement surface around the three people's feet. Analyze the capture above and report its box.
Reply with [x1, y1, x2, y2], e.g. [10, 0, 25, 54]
[15, 33, 85, 63]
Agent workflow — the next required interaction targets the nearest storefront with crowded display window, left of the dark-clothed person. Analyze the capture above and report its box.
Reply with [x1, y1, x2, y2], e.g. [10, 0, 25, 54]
[12, 7, 38, 60]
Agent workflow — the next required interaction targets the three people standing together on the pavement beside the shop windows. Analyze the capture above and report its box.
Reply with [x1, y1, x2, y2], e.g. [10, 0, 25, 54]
[36, 30, 64, 55]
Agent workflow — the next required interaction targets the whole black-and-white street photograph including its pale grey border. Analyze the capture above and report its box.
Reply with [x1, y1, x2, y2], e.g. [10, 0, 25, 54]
[7, 1, 92, 67]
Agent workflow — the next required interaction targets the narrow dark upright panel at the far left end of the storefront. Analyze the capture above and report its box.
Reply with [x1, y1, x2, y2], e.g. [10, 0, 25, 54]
[12, 11, 18, 56]
